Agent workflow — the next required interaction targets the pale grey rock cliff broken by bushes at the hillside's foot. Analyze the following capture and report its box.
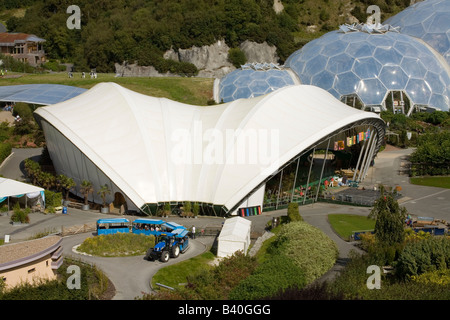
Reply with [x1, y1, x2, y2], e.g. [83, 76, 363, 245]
[115, 40, 278, 78]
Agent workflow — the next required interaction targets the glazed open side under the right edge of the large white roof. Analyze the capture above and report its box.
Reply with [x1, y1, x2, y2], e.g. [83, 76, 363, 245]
[263, 124, 382, 211]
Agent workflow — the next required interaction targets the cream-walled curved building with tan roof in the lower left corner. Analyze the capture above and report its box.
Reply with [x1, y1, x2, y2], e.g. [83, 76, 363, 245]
[0, 236, 63, 288]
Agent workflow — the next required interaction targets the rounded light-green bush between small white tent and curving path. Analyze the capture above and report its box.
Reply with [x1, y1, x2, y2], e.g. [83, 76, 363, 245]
[268, 221, 338, 283]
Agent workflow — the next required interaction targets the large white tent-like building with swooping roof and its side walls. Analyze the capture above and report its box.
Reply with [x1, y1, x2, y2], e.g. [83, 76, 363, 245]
[35, 83, 385, 216]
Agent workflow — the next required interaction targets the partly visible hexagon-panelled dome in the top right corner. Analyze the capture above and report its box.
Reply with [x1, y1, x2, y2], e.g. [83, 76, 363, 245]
[385, 0, 450, 64]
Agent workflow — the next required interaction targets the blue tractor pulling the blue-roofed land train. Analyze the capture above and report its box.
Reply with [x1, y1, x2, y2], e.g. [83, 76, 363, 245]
[145, 228, 189, 262]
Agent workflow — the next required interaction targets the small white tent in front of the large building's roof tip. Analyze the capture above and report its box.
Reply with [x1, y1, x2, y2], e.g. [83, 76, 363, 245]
[217, 217, 252, 257]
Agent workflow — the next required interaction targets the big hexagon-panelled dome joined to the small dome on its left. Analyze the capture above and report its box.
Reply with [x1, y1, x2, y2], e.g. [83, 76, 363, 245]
[216, 19, 450, 115]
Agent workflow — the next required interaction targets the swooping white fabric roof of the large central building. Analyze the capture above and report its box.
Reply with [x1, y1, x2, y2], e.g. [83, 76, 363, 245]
[35, 83, 382, 209]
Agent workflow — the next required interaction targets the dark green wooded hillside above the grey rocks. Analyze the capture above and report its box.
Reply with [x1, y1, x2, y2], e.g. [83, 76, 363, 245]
[0, 0, 410, 72]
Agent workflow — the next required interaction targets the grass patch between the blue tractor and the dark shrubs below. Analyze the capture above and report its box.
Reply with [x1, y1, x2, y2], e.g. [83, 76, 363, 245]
[150, 251, 215, 290]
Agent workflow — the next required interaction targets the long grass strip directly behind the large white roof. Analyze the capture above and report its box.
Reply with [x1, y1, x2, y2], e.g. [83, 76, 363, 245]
[0, 72, 214, 106]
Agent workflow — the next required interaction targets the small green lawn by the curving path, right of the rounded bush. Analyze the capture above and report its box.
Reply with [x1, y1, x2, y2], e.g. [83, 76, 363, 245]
[328, 214, 375, 241]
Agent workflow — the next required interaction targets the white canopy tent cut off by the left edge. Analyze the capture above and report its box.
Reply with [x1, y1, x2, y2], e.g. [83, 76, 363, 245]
[0, 178, 45, 210]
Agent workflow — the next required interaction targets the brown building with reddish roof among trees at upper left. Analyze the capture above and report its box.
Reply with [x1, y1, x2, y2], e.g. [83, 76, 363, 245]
[0, 32, 46, 67]
